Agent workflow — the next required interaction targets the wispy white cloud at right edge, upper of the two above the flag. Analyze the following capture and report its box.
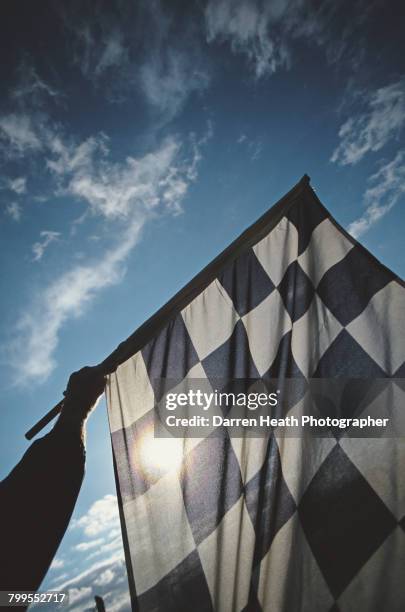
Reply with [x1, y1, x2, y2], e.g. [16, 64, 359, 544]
[331, 79, 405, 165]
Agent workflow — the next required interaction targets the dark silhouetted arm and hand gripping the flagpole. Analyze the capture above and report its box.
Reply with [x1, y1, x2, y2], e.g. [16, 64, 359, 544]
[0, 368, 104, 591]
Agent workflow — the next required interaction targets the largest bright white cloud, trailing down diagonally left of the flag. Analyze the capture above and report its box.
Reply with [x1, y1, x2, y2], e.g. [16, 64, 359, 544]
[7, 126, 212, 384]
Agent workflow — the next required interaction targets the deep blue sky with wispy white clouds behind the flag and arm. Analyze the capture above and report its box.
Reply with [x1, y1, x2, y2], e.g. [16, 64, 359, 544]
[0, 0, 405, 611]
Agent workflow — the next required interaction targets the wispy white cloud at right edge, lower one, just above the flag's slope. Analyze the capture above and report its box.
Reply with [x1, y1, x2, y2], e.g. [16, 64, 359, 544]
[348, 150, 405, 238]
